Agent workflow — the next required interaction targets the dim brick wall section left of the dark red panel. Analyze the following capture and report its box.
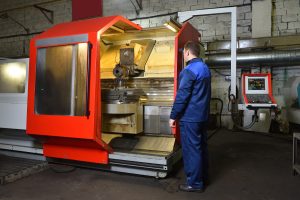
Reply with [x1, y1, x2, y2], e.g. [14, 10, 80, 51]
[0, 0, 72, 57]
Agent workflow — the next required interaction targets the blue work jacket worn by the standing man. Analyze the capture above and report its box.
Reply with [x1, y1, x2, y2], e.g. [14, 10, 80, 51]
[170, 58, 211, 122]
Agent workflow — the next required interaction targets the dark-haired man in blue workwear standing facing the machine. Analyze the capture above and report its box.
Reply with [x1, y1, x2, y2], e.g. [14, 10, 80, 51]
[169, 41, 211, 192]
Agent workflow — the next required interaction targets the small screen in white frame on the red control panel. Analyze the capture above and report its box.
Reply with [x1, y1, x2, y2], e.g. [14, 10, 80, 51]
[245, 76, 269, 94]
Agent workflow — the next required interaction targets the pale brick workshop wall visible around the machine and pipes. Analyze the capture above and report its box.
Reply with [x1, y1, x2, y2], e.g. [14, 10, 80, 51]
[0, 0, 300, 130]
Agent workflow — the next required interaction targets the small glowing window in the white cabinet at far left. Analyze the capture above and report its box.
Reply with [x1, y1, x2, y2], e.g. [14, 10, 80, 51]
[0, 62, 26, 93]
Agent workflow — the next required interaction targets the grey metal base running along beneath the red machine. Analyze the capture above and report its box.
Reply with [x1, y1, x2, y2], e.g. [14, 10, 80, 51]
[0, 129, 182, 178]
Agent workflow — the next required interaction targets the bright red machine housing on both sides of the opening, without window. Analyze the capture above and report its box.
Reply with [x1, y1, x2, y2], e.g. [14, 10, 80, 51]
[27, 16, 200, 164]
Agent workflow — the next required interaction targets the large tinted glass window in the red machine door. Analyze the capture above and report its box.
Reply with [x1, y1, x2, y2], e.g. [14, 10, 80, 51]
[35, 43, 88, 116]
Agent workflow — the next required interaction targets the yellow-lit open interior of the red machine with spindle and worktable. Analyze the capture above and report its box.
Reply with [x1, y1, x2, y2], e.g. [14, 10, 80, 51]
[100, 27, 175, 155]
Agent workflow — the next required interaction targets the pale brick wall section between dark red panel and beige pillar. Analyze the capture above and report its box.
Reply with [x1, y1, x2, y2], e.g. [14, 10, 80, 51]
[104, 0, 251, 42]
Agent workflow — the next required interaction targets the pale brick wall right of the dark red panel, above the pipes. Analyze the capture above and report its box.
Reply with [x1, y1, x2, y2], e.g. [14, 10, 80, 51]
[104, 0, 300, 42]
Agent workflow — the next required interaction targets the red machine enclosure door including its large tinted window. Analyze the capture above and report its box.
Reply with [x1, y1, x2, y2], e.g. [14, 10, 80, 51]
[27, 16, 140, 164]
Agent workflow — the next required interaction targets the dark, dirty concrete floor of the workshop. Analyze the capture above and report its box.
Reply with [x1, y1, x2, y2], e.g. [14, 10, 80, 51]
[0, 130, 300, 200]
